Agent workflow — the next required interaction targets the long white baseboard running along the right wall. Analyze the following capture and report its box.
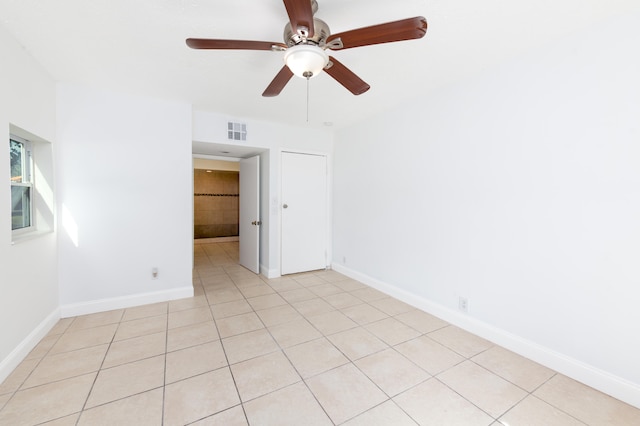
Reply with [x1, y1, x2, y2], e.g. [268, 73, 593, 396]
[331, 264, 640, 408]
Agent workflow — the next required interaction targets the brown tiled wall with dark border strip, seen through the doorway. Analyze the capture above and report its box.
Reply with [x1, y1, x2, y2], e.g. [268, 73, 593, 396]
[193, 169, 240, 238]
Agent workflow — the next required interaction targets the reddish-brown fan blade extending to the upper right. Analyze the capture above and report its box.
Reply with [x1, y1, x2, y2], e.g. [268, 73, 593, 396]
[327, 16, 427, 50]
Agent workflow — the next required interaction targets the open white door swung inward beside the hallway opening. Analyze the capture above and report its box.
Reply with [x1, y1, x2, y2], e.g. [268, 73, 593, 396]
[239, 156, 261, 274]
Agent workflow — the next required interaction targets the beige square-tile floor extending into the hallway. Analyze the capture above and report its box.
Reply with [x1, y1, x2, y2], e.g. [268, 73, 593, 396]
[0, 243, 640, 426]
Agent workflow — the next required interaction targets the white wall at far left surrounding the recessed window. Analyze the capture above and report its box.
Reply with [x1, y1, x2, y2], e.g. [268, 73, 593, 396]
[0, 27, 59, 382]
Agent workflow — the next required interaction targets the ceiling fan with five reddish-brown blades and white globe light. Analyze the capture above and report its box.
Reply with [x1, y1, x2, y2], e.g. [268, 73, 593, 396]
[186, 0, 427, 96]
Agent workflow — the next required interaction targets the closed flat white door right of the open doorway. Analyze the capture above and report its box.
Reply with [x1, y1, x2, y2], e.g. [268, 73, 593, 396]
[281, 152, 327, 274]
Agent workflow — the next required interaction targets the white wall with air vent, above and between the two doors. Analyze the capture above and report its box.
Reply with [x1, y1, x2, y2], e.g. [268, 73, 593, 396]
[193, 111, 333, 277]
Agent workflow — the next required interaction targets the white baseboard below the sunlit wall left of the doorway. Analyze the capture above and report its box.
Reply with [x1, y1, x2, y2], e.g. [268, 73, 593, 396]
[60, 286, 193, 318]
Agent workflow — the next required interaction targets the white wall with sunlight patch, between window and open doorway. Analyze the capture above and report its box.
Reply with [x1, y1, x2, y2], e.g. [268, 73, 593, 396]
[57, 84, 193, 316]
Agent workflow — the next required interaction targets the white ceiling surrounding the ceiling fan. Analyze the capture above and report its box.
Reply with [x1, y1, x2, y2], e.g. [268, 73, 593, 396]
[0, 0, 640, 127]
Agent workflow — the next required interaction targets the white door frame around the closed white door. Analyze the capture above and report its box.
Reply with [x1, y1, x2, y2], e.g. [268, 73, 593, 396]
[278, 148, 333, 275]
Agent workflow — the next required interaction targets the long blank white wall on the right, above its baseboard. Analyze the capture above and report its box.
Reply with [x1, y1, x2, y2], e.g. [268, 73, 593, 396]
[333, 14, 640, 406]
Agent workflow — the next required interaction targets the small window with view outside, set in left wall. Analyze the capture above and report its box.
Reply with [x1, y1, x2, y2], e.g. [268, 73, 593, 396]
[9, 135, 34, 231]
